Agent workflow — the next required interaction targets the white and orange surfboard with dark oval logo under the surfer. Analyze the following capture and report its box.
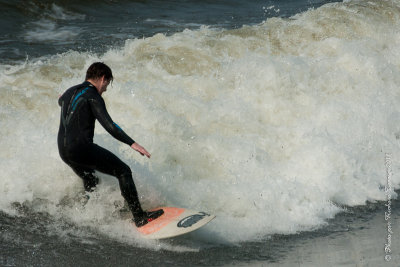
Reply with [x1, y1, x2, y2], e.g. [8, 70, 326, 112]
[137, 207, 215, 239]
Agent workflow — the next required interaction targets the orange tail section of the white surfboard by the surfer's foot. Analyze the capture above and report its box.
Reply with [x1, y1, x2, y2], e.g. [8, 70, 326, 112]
[137, 207, 185, 235]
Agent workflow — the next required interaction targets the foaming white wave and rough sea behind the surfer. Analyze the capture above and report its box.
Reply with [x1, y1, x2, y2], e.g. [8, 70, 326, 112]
[0, 0, 400, 263]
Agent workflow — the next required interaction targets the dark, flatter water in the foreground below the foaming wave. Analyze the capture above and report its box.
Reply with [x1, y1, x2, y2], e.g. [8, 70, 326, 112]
[0, 197, 400, 266]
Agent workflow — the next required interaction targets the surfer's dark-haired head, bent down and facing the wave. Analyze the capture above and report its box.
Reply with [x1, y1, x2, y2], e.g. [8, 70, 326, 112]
[85, 62, 114, 95]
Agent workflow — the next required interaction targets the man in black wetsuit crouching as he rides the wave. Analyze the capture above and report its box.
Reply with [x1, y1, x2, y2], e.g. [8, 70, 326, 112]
[57, 62, 164, 227]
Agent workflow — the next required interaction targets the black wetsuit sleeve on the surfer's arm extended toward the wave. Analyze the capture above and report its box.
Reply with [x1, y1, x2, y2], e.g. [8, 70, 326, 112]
[89, 96, 135, 146]
